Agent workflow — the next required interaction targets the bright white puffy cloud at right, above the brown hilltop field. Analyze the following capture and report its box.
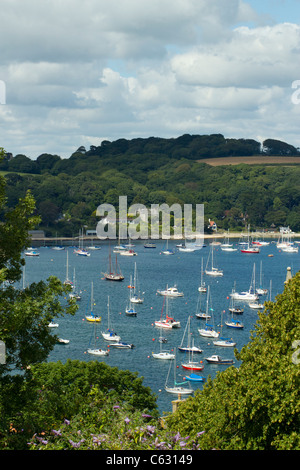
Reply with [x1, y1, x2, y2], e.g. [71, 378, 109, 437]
[171, 24, 300, 88]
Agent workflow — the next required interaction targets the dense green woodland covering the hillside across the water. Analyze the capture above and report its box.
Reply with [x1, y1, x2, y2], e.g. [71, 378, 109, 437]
[0, 134, 300, 237]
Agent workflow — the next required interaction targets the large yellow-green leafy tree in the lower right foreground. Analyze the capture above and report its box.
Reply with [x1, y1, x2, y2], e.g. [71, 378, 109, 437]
[167, 272, 300, 450]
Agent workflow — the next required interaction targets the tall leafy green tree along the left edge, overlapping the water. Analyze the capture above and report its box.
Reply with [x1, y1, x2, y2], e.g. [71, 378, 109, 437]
[0, 150, 76, 448]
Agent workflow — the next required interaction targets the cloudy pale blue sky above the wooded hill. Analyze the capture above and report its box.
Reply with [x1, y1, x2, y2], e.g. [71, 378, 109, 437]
[0, 0, 300, 159]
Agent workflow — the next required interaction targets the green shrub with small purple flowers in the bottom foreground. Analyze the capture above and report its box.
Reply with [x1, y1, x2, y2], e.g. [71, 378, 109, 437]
[29, 404, 202, 450]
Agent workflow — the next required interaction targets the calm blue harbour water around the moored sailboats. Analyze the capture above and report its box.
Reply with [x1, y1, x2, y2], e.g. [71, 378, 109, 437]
[25, 240, 300, 412]
